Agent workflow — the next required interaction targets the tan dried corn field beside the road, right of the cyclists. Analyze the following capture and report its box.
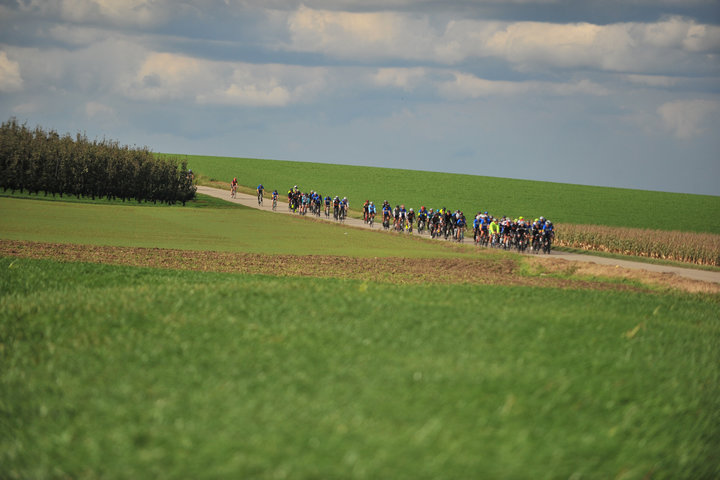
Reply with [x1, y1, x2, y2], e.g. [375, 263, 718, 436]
[555, 224, 720, 266]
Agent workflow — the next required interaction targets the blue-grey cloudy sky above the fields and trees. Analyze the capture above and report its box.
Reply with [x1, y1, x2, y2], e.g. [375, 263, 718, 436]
[0, 0, 720, 196]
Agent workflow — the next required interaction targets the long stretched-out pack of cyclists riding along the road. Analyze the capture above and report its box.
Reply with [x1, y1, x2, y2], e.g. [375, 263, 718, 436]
[231, 178, 555, 253]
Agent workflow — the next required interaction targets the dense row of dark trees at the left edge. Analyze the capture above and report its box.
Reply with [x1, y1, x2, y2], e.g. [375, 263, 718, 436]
[0, 118, 196, 205]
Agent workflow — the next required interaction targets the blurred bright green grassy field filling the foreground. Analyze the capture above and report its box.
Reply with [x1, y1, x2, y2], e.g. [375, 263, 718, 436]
[0, 258, 720, 479]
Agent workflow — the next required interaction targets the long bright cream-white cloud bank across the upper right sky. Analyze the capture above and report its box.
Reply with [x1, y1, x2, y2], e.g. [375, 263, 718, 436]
[281, 6, 720, 74]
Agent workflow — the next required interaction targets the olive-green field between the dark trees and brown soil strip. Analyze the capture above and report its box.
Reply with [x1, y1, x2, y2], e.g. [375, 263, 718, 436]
[0, 197, 484, 257]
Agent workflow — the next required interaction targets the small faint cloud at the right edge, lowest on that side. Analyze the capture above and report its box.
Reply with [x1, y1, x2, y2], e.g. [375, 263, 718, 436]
[657, 100, 720, 140]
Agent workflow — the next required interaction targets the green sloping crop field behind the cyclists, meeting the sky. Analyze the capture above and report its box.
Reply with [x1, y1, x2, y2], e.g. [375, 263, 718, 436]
[172, 155, 720, 233]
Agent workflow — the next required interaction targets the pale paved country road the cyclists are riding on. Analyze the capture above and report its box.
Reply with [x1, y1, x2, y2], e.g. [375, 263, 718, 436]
[198, 185, 720, 283]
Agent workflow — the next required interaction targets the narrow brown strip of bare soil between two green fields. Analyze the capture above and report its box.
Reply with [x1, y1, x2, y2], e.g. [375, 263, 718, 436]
[5, 240, 720, 293]
